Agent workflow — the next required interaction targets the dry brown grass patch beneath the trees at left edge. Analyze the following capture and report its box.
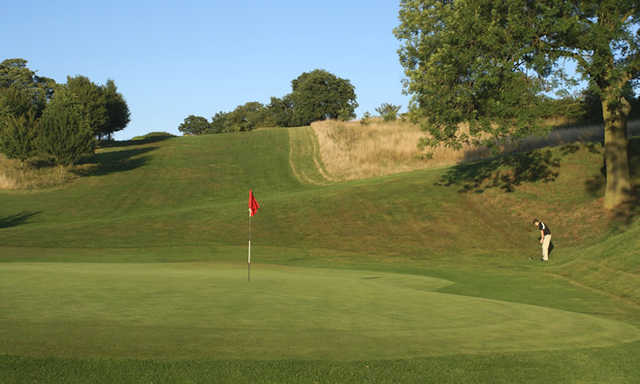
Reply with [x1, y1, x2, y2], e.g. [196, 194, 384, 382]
[0, 154, 77, 190]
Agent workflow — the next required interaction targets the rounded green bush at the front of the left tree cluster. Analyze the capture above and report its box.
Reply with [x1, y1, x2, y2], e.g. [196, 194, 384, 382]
[38, 88, 95, 165]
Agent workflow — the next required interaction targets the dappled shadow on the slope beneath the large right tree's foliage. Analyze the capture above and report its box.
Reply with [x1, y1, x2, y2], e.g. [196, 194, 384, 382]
[436, 146, 560, 193]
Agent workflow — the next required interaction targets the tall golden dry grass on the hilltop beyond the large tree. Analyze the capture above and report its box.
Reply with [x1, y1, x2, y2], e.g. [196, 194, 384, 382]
[311, 119, 640, 180]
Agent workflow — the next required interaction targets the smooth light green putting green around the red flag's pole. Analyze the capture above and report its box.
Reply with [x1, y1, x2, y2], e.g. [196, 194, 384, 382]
[0, 263, 640, 360]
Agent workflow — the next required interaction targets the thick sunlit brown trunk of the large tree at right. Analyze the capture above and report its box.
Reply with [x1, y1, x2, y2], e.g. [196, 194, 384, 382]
[602, 92, 631, 210]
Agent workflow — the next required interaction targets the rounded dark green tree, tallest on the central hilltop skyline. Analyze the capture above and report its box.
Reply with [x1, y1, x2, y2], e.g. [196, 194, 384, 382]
[290, 69, 358, 125]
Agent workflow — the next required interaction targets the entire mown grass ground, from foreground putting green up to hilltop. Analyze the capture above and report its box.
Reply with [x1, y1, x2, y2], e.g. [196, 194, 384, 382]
[0, 127, 640, 383]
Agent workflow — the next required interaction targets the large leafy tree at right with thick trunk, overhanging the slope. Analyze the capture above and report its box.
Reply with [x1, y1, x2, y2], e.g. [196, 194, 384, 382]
[394, 0, 640, 209]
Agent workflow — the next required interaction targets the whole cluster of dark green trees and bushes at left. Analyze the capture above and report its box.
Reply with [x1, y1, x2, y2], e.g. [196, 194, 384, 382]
[0, 59, 130, 165]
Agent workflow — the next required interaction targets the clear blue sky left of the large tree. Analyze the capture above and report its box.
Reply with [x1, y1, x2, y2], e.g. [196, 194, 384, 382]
[0, 0, 409, 139]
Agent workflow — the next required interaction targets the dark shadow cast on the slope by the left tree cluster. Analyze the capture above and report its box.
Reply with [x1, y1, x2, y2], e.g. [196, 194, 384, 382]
[73, 147, 158, 176]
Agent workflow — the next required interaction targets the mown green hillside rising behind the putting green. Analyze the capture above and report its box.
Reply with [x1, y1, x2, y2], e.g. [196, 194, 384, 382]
[0, 128, 638, 296]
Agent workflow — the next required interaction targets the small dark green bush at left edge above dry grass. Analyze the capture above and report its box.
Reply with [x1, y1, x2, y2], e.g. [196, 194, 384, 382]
[0, 112, 38, 162]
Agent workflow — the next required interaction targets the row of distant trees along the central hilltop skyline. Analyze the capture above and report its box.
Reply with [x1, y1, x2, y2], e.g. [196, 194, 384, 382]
[178, 69, 358, 135]
